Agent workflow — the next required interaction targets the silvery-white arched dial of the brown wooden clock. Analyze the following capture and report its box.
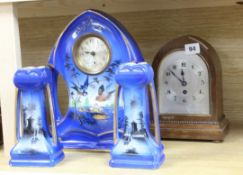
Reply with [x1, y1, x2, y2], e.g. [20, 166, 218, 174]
[158, 50, 210, 115]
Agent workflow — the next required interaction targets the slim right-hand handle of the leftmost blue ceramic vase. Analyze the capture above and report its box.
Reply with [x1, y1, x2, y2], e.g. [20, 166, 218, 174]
[46, 85, 57, 146]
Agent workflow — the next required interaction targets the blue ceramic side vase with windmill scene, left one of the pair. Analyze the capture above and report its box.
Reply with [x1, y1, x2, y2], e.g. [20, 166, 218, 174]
[9, 67, 64, 166]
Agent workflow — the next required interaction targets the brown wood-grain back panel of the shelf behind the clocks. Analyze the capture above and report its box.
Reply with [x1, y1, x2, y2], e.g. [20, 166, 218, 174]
[19, 6, 243, 120]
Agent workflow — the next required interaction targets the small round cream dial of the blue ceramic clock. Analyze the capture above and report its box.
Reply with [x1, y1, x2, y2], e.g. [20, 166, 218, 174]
[73, 36, 110, 74]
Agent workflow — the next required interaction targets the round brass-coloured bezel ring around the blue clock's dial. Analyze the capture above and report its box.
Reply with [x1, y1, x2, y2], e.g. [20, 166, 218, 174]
[72, 33, 112, 75]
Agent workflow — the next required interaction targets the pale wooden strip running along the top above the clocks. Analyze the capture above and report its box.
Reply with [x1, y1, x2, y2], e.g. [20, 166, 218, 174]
[15, 0, 237, 18]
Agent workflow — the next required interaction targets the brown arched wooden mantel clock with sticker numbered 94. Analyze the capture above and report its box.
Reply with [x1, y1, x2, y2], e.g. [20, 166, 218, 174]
[153, 36, 229, 141]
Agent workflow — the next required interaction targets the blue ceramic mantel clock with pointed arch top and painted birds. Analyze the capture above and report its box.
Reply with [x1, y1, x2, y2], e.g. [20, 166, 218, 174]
[49, 10, 143, 150]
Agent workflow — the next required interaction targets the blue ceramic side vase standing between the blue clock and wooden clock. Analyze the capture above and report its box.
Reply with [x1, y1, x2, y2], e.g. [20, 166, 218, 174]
[110, 62, 165, 169]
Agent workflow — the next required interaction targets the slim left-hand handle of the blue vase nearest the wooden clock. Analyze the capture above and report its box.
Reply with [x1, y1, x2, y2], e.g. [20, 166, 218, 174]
[113, 85, 121, 144]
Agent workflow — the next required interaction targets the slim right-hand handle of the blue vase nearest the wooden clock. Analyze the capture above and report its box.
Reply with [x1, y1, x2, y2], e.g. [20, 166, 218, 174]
[149, 82, 160, 143]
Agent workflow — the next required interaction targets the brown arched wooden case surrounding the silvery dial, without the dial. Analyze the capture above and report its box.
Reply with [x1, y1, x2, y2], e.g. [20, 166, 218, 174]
[152, 36, 229, 141]
